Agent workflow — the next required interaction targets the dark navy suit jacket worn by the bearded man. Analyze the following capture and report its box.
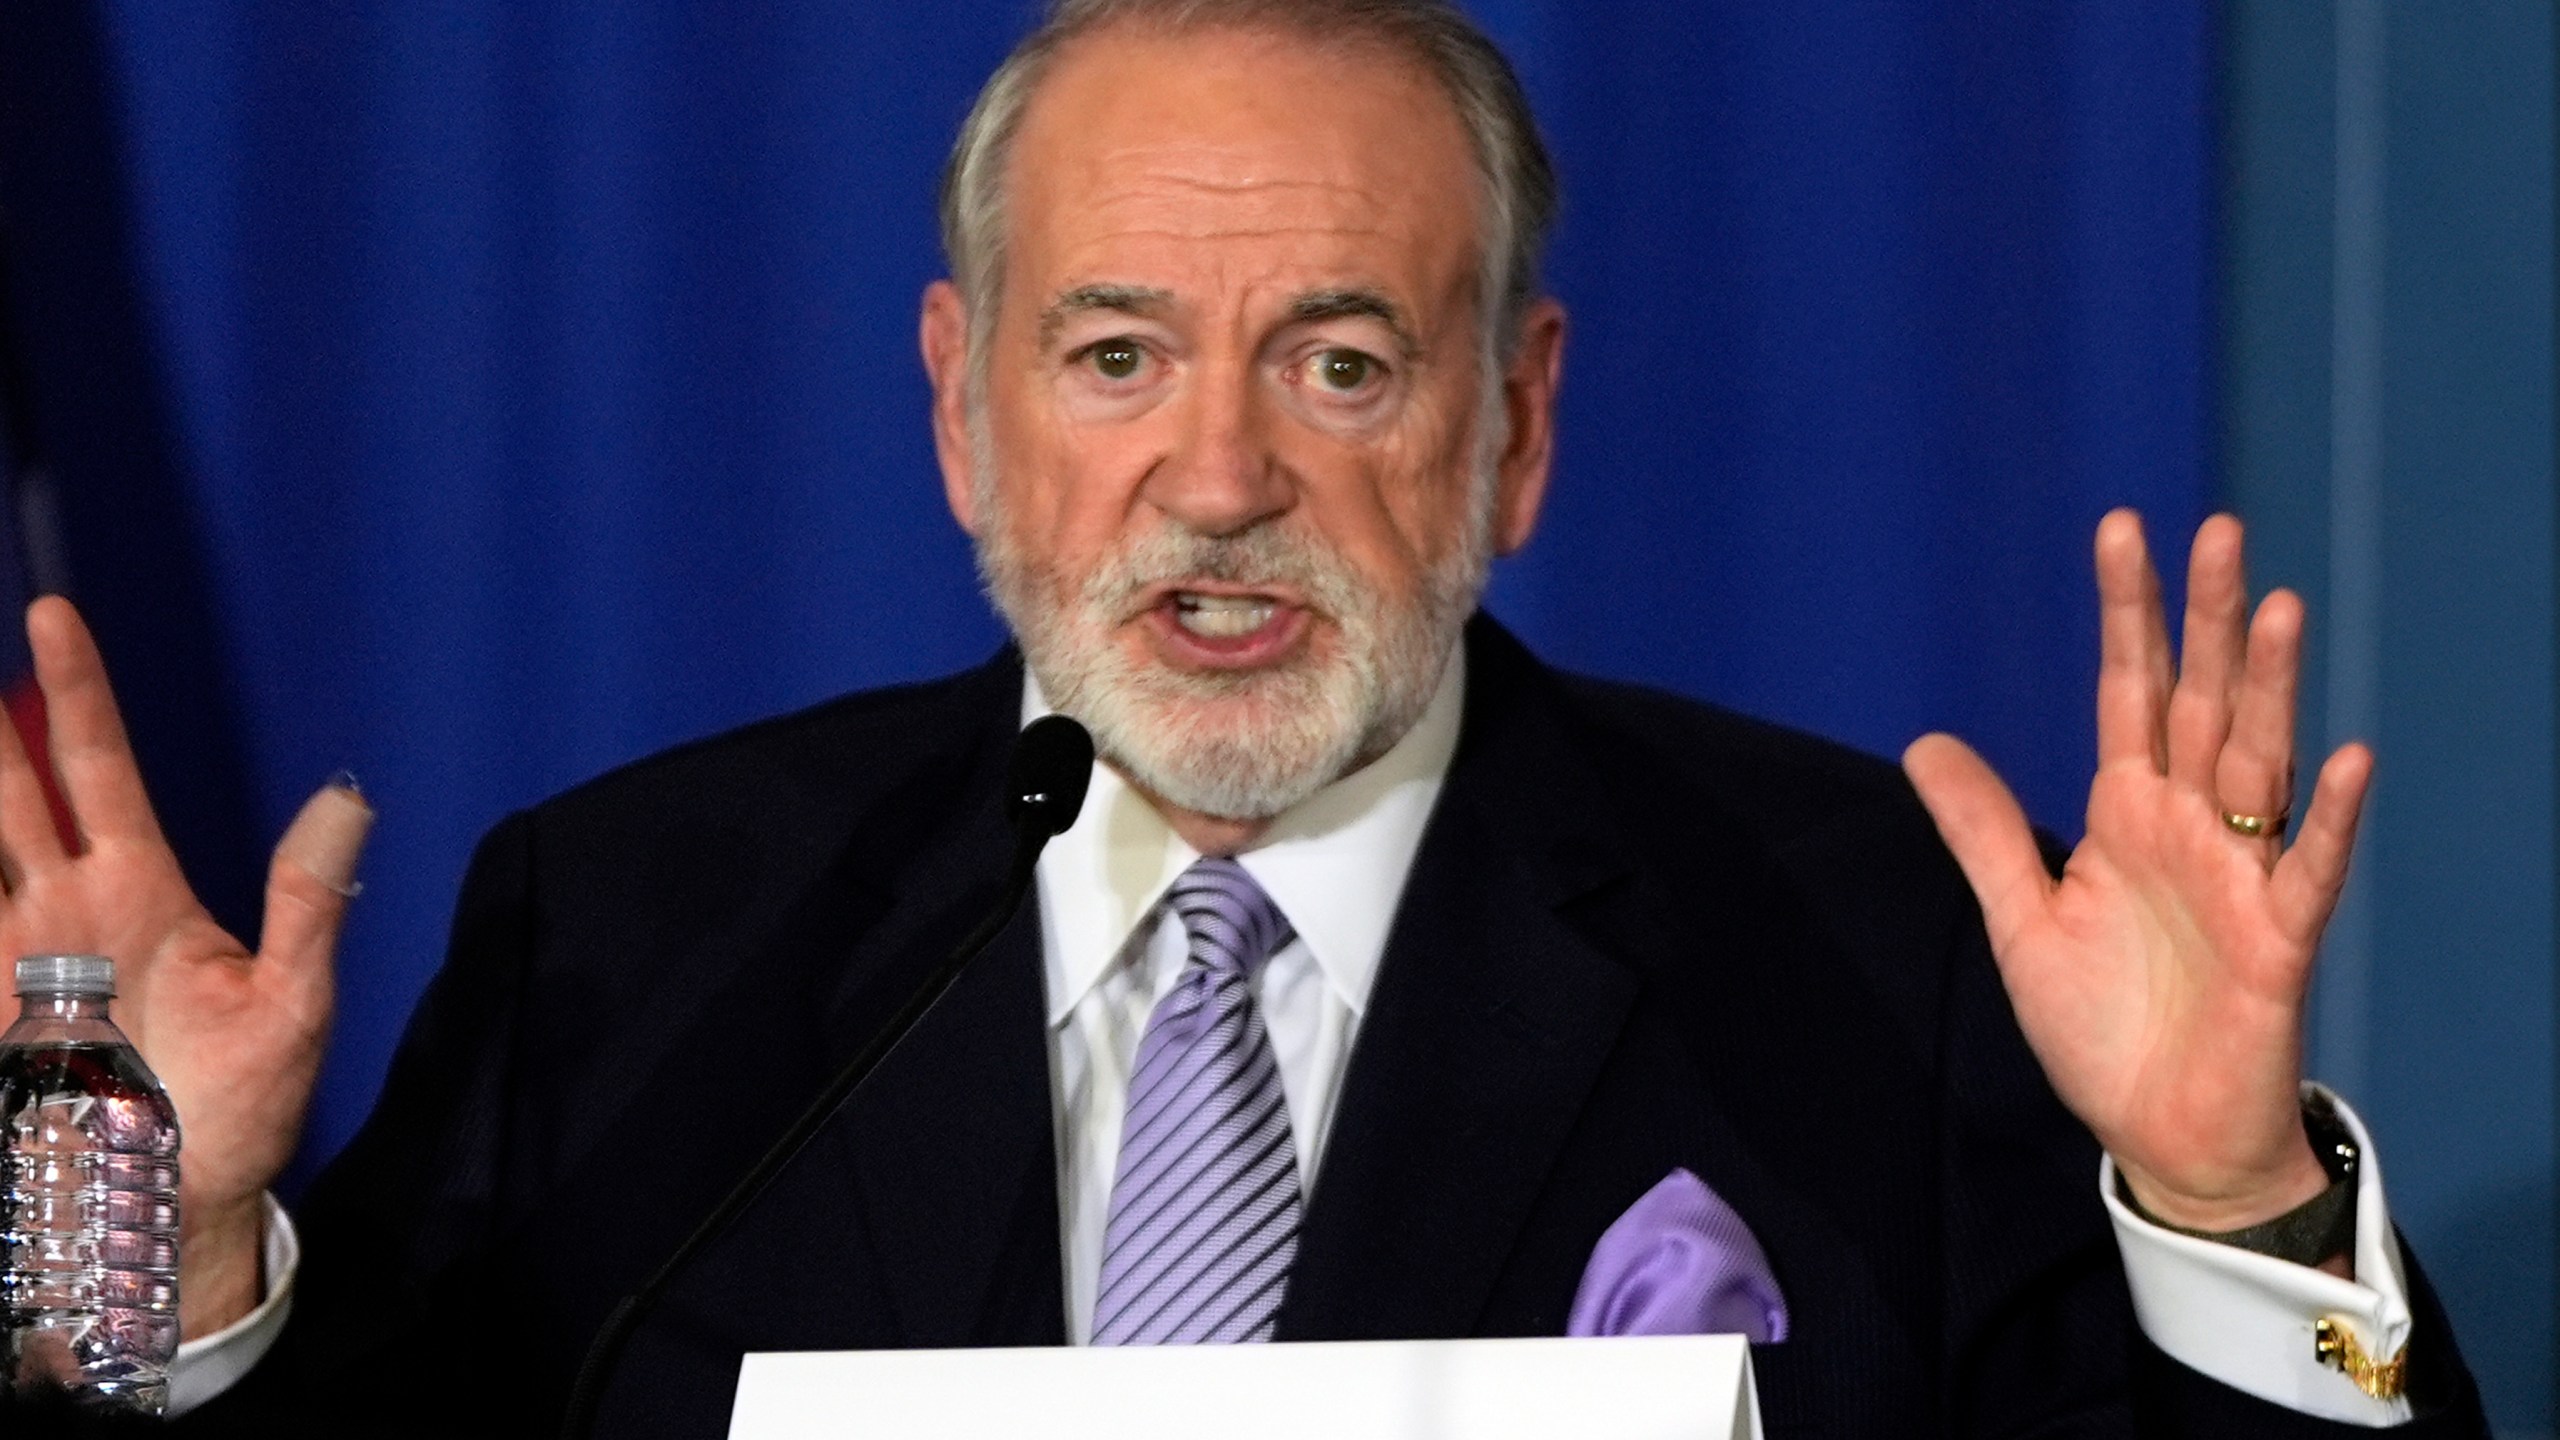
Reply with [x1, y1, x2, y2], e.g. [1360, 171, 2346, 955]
[182, 609, 2486, 1437]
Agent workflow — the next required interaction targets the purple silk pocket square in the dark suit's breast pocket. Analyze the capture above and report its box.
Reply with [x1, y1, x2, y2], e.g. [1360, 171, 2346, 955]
[1564, 1171, 1787, 1345]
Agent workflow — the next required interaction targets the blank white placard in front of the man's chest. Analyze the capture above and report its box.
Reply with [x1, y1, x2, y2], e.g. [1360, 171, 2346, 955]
[730, 1335, 1761, 1440]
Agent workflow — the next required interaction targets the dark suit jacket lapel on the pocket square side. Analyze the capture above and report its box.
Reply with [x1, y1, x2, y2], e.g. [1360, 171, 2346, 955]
[1280, 620, 1636, 1340]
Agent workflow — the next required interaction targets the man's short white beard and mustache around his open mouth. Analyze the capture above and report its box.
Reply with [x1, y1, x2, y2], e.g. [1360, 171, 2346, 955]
[970, 425, 1495, 820]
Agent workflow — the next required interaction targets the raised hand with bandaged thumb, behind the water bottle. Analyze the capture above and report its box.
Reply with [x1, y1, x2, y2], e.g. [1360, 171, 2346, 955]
[0, 597, 374, 1338]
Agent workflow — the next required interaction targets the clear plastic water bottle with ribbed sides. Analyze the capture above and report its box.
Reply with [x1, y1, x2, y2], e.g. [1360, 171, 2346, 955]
[0, 956, 177, 1414]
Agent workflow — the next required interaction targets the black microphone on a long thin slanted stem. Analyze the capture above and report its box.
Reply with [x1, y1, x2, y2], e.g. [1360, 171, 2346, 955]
[561, 715, 1093, 1440]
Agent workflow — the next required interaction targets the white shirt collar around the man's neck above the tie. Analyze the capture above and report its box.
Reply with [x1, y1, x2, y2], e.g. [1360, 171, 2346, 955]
[1021, 646, 1467, 1027]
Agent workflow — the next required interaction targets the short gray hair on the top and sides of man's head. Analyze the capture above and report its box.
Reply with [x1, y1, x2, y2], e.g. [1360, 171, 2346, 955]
[942, 0, 1556, 372]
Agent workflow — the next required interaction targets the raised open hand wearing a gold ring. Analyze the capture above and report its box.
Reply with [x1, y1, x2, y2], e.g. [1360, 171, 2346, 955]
[1902, 510, 2373, 1230]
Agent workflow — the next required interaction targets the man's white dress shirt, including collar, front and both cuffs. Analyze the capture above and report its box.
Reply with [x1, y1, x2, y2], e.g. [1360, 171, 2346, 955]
[169, 653, 2409, 1427]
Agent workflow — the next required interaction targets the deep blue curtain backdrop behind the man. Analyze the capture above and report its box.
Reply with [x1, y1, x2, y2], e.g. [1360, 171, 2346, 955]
[64, 0, 2212, 1188]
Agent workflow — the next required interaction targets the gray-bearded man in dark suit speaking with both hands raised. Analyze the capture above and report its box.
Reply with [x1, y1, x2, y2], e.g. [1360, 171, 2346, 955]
[0, 0, 2486, 1437]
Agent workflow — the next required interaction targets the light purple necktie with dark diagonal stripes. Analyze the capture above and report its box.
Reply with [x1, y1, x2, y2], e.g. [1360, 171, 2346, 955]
[1093, 858, 1298, 1345]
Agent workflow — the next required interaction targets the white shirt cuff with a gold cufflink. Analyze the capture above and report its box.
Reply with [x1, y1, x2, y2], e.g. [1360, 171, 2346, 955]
[2097, 1086, 2409, 1427]
